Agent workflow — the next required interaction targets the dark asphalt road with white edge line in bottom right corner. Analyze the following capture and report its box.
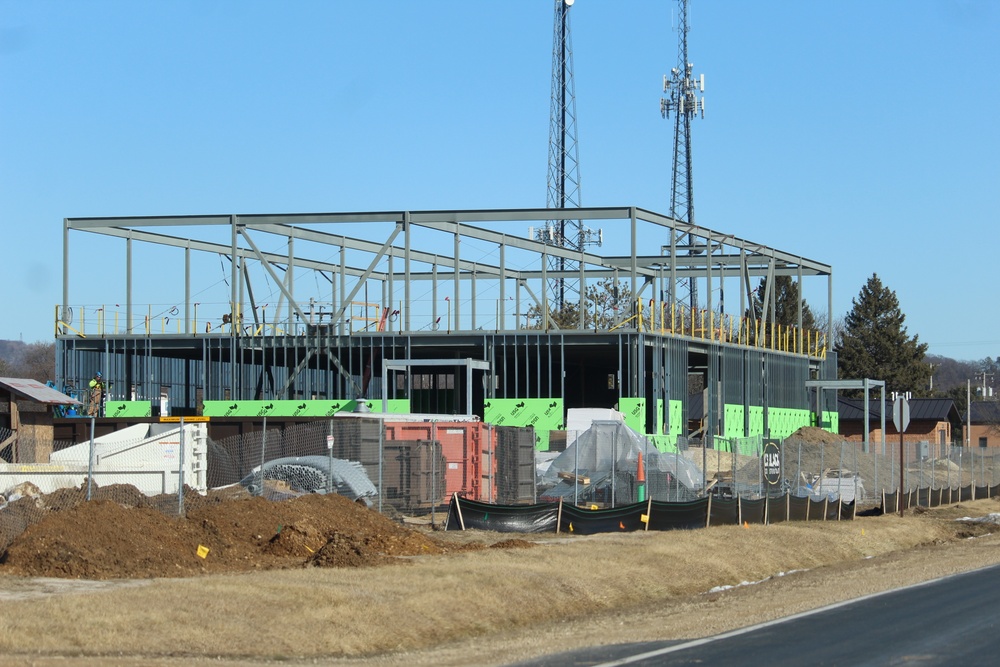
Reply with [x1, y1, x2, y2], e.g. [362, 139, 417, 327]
[519, 566, 1000, 667]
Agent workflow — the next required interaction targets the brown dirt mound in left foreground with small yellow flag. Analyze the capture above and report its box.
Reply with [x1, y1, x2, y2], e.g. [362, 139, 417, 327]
[0, 487, 447, 579]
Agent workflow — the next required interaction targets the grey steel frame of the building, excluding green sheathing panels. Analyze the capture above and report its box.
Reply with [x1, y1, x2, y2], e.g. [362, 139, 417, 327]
[55, 207, 836, 444]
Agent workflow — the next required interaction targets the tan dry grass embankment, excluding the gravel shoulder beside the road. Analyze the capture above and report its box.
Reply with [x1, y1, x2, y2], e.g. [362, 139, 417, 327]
[0, 500, 1000, 660]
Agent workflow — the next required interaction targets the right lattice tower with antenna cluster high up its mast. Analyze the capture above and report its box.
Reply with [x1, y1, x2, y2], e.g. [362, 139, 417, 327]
[660, 0, 705, 309]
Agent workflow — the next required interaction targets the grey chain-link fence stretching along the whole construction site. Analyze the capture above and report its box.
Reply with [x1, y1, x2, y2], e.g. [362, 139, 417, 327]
[0, 416, 1000, 548]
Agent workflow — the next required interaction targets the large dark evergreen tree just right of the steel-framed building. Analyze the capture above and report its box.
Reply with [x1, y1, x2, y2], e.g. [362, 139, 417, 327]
[834, 274, 932, 396]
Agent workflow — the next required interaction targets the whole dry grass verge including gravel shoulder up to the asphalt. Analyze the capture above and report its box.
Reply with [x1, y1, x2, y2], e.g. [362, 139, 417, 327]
[0, 499, 1000, 666]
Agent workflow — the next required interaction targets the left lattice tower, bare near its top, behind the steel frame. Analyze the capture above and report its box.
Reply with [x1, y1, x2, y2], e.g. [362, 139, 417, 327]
[533, 0, 601, 310]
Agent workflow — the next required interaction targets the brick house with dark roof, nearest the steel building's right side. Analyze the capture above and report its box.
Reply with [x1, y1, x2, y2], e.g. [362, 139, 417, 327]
[837, 397, 964, 457]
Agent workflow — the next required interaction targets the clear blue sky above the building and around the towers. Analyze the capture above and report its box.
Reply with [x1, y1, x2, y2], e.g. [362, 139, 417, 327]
[0, 0, 1000, 359]
